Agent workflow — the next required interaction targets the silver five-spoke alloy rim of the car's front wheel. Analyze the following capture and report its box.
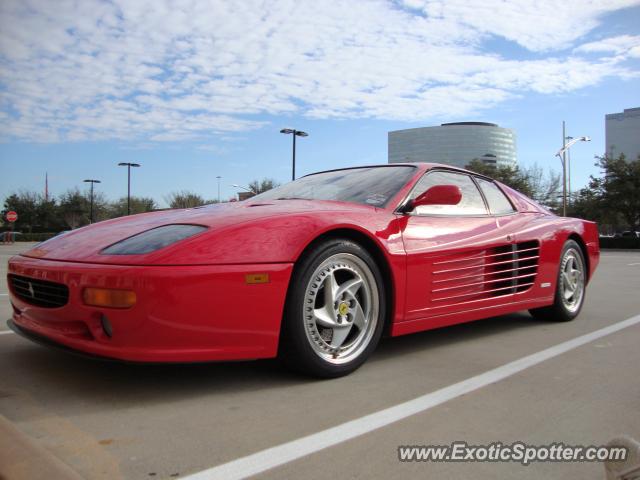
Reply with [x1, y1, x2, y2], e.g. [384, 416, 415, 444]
[303, 253, 379, 364]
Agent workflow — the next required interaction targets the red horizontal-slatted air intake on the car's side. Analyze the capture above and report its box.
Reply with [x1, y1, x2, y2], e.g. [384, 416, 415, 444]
[431, 241, 540, 306]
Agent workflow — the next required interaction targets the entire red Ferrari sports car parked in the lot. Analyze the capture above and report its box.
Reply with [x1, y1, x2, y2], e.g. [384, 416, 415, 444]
[8, 164, 599, 377]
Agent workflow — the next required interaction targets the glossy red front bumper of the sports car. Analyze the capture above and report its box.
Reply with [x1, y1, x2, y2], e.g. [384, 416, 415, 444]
[9, 257, 293, 362]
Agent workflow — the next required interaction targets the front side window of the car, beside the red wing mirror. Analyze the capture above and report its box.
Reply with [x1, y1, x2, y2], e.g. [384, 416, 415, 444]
[409, 170, 487, 215]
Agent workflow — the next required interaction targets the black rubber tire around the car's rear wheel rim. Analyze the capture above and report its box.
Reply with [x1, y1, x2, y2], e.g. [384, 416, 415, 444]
[529, 240, 588, 322]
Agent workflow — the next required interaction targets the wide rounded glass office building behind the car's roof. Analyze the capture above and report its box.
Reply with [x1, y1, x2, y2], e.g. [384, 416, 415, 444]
[389, 122, 518, 167]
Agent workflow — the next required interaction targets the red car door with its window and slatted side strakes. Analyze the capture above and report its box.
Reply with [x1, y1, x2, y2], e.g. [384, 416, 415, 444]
[402, 170, 513, 321]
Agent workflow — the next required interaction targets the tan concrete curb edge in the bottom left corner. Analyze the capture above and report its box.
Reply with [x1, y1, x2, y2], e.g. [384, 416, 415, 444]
[0, 415, 82, 480]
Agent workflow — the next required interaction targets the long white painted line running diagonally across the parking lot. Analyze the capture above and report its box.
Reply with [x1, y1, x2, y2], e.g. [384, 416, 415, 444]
[182, 315, 640, 480]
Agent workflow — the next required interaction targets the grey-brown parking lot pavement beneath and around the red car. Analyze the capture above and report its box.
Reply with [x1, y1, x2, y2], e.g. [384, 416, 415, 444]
[0, 244, 640, 479]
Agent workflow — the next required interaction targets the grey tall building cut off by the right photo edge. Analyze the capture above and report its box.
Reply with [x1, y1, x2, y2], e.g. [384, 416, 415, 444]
[604, 107, 640, 160]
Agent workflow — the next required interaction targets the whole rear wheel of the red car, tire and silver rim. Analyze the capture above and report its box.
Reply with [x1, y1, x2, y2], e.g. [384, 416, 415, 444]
[529, 240, 587, 322]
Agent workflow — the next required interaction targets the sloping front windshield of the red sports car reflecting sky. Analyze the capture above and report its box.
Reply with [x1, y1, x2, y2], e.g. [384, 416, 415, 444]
[251, 166, 415, 207]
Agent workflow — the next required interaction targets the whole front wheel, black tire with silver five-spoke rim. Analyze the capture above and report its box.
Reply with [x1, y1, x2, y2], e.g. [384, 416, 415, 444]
[279, 239, 386, 378]
